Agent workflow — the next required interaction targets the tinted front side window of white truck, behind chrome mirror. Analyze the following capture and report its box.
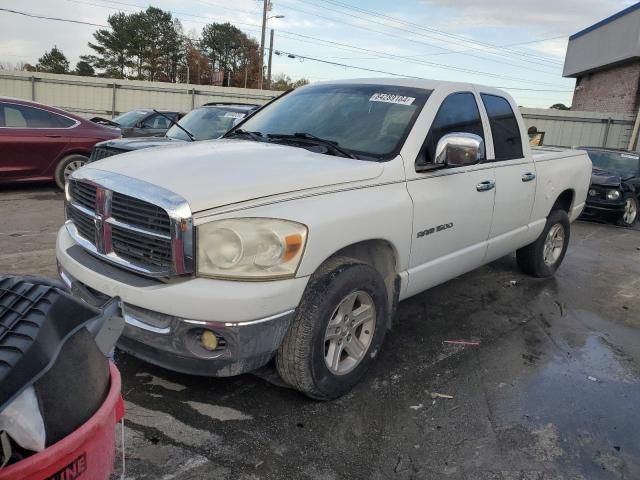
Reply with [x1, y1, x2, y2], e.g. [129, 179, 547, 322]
[418, 92, 484, 163]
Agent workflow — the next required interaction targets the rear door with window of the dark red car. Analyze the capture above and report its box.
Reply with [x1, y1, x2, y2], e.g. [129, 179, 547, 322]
[0, 102, 77, 180]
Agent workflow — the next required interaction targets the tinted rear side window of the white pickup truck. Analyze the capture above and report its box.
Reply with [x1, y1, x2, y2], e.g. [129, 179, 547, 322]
[481, 94, 522, 161]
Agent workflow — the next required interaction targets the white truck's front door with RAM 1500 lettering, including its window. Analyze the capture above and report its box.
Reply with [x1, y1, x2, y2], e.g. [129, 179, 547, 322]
[407, 91, 495, 295]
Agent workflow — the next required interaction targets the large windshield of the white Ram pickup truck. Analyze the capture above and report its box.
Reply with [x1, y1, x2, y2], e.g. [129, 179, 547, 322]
[230, 84, 431, 160]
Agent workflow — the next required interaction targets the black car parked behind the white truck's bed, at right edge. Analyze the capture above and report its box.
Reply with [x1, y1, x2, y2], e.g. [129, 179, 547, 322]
[578, 147, 640, 227]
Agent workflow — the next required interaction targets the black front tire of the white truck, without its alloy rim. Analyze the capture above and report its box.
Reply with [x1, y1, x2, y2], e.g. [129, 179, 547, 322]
[276, 258, 390, 400]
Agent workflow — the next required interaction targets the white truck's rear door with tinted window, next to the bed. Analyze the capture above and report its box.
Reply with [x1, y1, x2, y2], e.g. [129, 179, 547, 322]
[480, 93, 537, 261]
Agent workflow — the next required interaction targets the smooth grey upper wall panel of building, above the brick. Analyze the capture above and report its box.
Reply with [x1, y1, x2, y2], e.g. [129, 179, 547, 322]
[563, 4, 640, 77]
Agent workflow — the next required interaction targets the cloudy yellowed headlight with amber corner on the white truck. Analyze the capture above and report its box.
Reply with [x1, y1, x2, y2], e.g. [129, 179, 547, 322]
[197, 218, 307, 280]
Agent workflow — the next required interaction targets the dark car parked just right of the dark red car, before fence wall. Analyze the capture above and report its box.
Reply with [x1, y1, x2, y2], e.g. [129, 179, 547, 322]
[91, 108, 183, 137]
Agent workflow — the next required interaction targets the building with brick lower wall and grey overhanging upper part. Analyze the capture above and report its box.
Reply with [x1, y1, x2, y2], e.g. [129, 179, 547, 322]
[563, 3, 640, 113]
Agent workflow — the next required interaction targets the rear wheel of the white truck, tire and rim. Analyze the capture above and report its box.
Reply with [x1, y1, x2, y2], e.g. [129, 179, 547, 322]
[516, 210, 571, 278]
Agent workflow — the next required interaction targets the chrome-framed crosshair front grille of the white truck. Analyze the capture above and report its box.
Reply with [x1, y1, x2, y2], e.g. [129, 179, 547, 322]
[66, 172, 193, 276]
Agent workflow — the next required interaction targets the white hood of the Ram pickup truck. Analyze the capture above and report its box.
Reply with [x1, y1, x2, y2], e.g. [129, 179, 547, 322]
[91, 139, 384, 213]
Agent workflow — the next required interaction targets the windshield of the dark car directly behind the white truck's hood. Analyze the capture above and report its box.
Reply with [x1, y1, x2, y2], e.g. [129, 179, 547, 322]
[167, 107, 245, 141]
